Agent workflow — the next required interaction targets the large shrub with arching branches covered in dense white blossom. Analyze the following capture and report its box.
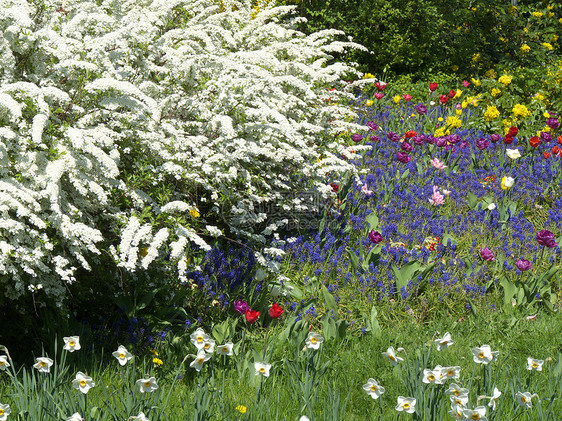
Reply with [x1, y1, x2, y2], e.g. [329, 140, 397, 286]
[0, 0, 364, 299]
